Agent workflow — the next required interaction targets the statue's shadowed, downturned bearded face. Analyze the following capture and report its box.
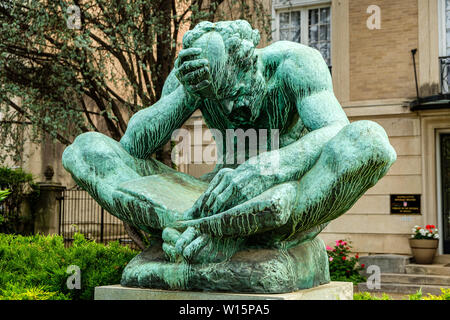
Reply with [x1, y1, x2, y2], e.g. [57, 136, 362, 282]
[211, 57, 266, 121]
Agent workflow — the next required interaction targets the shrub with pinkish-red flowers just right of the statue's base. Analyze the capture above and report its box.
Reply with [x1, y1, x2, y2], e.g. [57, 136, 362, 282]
[327, 240, 366, 284]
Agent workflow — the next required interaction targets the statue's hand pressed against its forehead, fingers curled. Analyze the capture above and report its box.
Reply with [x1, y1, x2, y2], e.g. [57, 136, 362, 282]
[175, 48, 214, 98]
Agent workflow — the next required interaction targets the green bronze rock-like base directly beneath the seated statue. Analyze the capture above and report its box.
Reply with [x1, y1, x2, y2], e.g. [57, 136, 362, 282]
[121, 238, 330, 293]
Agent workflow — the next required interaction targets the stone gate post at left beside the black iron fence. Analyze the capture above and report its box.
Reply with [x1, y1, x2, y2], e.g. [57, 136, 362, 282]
[34, 182, 66, 234]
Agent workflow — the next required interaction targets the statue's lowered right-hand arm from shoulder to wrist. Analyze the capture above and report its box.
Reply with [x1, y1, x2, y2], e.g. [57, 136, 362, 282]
[236, 46, 349, 185]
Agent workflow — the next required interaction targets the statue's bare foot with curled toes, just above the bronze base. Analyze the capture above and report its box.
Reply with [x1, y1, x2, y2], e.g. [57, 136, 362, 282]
[162, 183, 297, 262]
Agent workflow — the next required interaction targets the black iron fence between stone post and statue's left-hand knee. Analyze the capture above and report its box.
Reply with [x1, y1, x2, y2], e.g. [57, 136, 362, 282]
[59, 190, 137, 249]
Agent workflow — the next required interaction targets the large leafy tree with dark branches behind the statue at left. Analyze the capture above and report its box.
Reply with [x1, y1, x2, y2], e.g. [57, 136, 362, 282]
[0, 0, 270, 248]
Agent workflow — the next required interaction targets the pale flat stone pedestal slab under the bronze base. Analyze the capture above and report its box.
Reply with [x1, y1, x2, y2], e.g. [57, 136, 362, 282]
[95, 282, 353, 300]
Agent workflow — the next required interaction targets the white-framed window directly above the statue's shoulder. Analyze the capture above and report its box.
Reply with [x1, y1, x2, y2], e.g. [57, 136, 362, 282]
[274, 0, 332, 66]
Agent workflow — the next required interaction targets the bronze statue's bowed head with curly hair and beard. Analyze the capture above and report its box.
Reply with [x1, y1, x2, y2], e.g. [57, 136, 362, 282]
[183, 20, 264, 114]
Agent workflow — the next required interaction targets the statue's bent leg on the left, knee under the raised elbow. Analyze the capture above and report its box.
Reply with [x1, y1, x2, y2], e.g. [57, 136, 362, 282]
[63, 132, 185, 233]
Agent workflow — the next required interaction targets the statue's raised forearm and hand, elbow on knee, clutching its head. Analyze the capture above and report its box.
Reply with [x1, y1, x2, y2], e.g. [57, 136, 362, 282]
[120, 48, 211, 159]
